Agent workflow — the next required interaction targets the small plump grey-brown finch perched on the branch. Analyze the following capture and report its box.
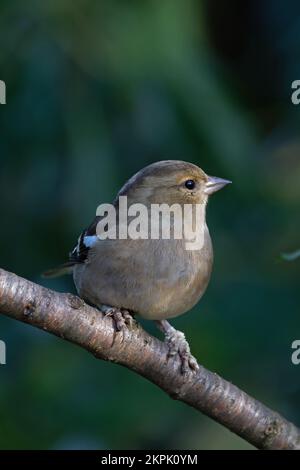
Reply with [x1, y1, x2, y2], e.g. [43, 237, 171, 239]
[46, 160, 230, 373]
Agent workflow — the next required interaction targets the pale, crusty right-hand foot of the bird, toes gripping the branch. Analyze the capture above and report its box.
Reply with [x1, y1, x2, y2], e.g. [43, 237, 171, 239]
[166, 330, 199, 375]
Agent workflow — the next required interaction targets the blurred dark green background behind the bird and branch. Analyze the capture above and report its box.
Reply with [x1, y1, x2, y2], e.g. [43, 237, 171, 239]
[0, 0, 300, 449]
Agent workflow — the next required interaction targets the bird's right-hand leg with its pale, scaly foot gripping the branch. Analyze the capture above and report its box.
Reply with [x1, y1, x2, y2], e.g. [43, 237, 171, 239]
[156, 320, 199, 374]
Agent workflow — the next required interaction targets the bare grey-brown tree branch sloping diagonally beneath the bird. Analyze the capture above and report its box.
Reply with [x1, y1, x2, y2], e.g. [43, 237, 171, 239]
[0, 269, 300, 449]
